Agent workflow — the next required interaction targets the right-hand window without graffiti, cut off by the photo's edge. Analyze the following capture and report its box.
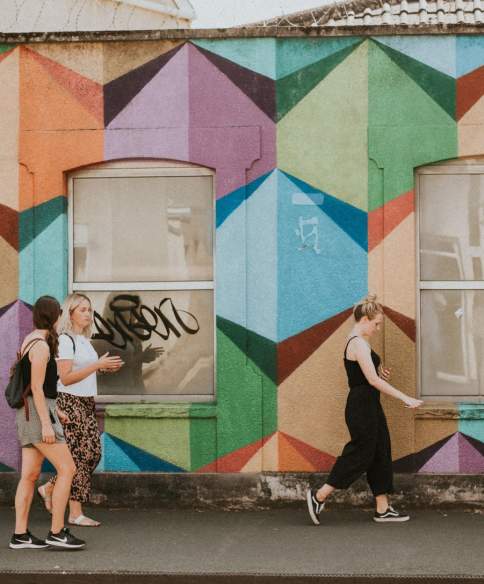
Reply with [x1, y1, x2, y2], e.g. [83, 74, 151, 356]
[417, 160, 484, 402]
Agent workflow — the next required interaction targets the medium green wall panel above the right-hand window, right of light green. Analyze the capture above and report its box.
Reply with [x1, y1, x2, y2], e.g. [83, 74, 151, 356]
[368, 41, 458, 211]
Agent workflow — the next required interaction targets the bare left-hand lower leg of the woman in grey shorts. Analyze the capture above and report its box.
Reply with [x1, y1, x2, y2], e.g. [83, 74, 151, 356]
[15, 448, 44, 535]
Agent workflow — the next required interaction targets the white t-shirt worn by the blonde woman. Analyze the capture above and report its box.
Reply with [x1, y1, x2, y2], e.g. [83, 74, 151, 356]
[57, 333, 99, 397]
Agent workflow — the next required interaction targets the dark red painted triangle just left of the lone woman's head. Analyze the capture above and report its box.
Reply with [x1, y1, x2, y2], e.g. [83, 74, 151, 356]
[277, 308, 352, 383]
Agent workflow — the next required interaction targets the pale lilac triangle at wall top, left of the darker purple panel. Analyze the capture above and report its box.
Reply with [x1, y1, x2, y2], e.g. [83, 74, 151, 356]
[108, 45, 188, 129]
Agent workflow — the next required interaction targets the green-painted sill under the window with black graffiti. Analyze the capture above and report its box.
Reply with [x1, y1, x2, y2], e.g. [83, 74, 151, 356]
[104, 403, 217, 418]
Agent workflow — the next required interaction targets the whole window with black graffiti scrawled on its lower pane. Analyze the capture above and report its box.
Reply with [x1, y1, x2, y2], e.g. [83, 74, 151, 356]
[69, 161, 214, 401]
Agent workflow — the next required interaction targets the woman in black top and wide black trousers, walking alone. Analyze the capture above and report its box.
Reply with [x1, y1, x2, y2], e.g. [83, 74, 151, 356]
[306, 295, 423, 525]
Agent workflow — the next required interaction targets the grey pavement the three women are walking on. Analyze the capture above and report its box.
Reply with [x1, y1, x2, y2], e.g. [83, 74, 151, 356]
[0, 504, 484, 584]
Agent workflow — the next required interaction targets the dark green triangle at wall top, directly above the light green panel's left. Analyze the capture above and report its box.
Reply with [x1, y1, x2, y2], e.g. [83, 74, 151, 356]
[276, 41, 361, 121]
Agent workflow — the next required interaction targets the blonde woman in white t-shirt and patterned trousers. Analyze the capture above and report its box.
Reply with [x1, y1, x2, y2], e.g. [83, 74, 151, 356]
[38, 293, 123, 527]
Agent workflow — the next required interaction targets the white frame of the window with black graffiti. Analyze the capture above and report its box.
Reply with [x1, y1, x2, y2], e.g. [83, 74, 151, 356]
[67, 159, 217, 404]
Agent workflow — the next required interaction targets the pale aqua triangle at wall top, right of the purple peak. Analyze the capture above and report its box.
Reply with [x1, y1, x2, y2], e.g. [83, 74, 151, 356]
[191, 38, 276, 79]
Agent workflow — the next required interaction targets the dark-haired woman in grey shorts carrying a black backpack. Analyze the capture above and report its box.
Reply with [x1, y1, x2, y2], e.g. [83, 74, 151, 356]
[10, 296, 85, 550]
